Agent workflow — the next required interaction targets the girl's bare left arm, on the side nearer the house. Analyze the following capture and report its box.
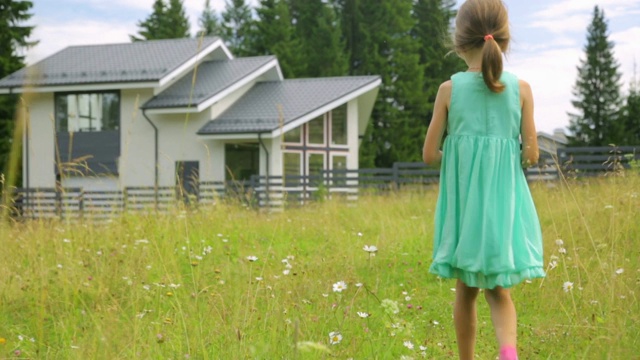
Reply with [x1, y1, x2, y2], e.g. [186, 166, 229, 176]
[422, 80, 451, 166]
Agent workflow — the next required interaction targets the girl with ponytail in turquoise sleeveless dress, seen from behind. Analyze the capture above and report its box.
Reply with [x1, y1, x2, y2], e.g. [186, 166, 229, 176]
[423, 0, 545, 360]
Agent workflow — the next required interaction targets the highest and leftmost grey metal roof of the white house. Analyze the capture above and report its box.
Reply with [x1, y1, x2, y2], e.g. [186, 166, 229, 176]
[0, 37, 218, 88]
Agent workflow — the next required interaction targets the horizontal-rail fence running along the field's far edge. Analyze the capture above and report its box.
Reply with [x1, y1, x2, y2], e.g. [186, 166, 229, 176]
[3, 147, 640, 220]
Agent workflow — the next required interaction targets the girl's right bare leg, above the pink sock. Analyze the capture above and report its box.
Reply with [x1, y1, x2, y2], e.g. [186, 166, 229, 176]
[484, 286, 517, 360]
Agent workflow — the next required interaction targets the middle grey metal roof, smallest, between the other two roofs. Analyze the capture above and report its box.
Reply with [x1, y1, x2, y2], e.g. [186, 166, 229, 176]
[142, 56, 275, 109]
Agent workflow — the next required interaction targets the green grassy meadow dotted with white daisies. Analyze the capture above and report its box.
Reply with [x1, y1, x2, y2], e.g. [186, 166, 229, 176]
[0, 174, 640, 359]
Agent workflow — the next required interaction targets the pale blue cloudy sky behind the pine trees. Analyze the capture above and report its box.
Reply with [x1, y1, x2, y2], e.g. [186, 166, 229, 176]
[20, 0, 640, 133]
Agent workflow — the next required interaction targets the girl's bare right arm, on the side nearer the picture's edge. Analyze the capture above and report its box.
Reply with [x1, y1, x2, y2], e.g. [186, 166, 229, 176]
[520, 80, 539, 167]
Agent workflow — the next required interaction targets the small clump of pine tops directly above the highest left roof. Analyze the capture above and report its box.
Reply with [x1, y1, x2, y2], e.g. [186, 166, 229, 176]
[129, 0, 190, 41]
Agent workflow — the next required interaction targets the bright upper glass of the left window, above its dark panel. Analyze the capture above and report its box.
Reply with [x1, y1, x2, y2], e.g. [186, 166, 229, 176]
[55, 91, 120, 132]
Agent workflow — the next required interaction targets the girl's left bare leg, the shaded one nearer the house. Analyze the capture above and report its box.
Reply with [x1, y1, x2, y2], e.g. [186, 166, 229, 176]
[453, 280, 478, 360]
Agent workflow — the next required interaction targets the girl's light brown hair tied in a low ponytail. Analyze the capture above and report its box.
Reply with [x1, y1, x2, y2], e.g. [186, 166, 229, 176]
[453, 0, 511, 93]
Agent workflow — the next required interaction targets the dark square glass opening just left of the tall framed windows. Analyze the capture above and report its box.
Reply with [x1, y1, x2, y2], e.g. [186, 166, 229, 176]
[224, 143, 260, 184]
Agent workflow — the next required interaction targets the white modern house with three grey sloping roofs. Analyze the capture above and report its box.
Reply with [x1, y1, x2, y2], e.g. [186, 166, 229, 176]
[0, 37, 381, 201]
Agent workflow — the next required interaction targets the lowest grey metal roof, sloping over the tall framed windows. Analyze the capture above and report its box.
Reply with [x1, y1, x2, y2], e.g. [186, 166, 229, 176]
[198, 76, 380, 135]
